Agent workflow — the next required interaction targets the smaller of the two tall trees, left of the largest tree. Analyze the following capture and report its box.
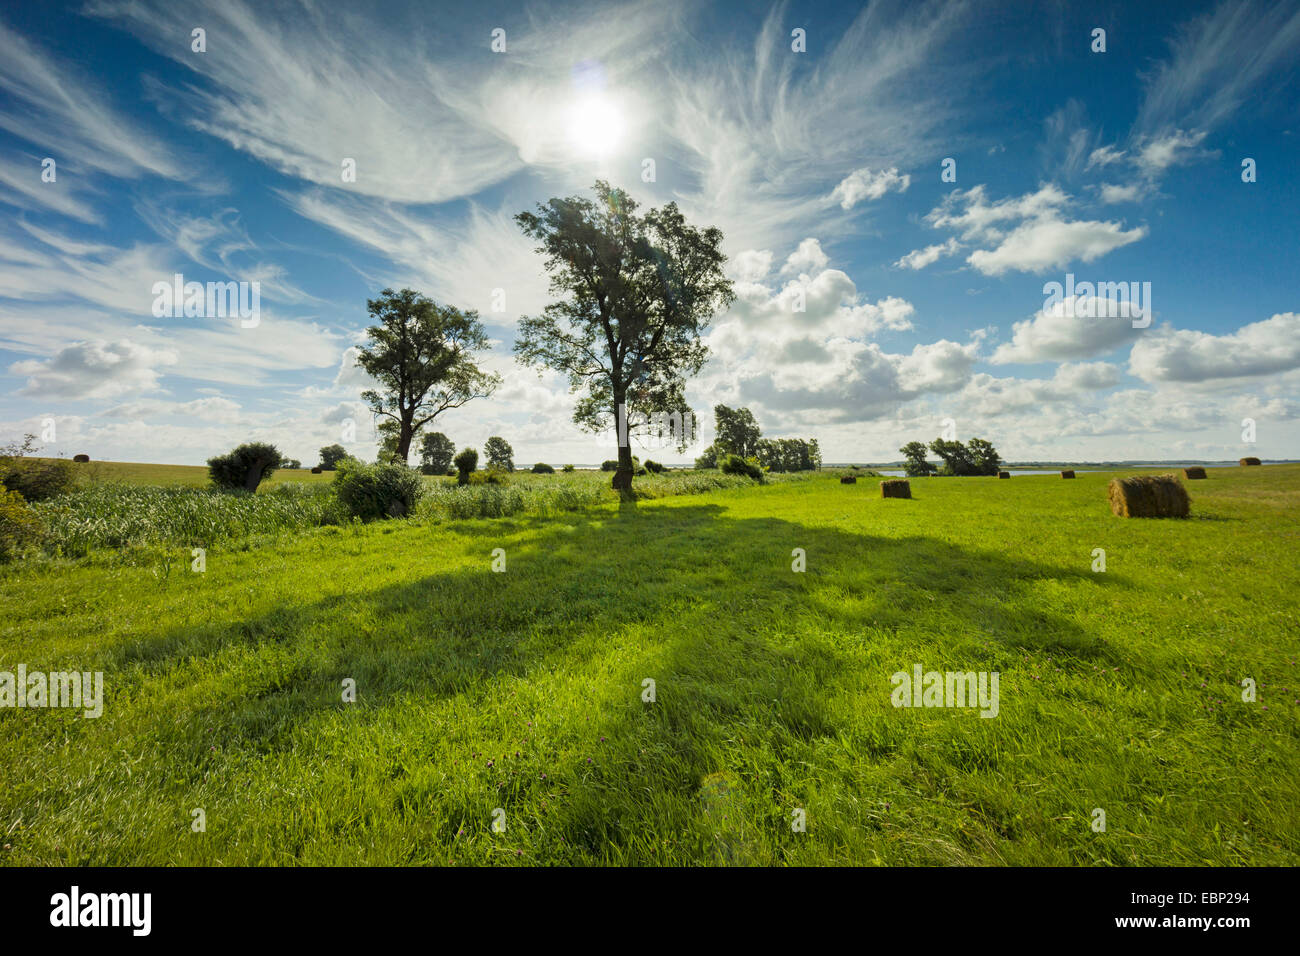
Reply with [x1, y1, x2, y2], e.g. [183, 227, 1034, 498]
[356, 289, 501, 462]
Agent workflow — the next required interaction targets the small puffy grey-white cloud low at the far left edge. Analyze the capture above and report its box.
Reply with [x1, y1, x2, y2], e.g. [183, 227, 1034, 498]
[9, 339, 177, 401]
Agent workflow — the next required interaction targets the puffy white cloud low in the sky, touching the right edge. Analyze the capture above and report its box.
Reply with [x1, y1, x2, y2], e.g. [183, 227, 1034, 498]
[1128, 312, 1300, 382]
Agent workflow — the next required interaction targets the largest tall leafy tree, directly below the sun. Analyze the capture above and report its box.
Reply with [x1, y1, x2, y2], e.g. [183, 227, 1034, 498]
[515, 181, 736, 496]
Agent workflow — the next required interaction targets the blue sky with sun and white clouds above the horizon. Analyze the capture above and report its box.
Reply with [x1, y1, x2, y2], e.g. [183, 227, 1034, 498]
[0, 0, 1300, 463]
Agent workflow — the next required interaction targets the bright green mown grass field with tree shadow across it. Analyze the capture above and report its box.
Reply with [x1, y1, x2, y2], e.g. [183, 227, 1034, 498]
[0, 466, 1300, 865]
